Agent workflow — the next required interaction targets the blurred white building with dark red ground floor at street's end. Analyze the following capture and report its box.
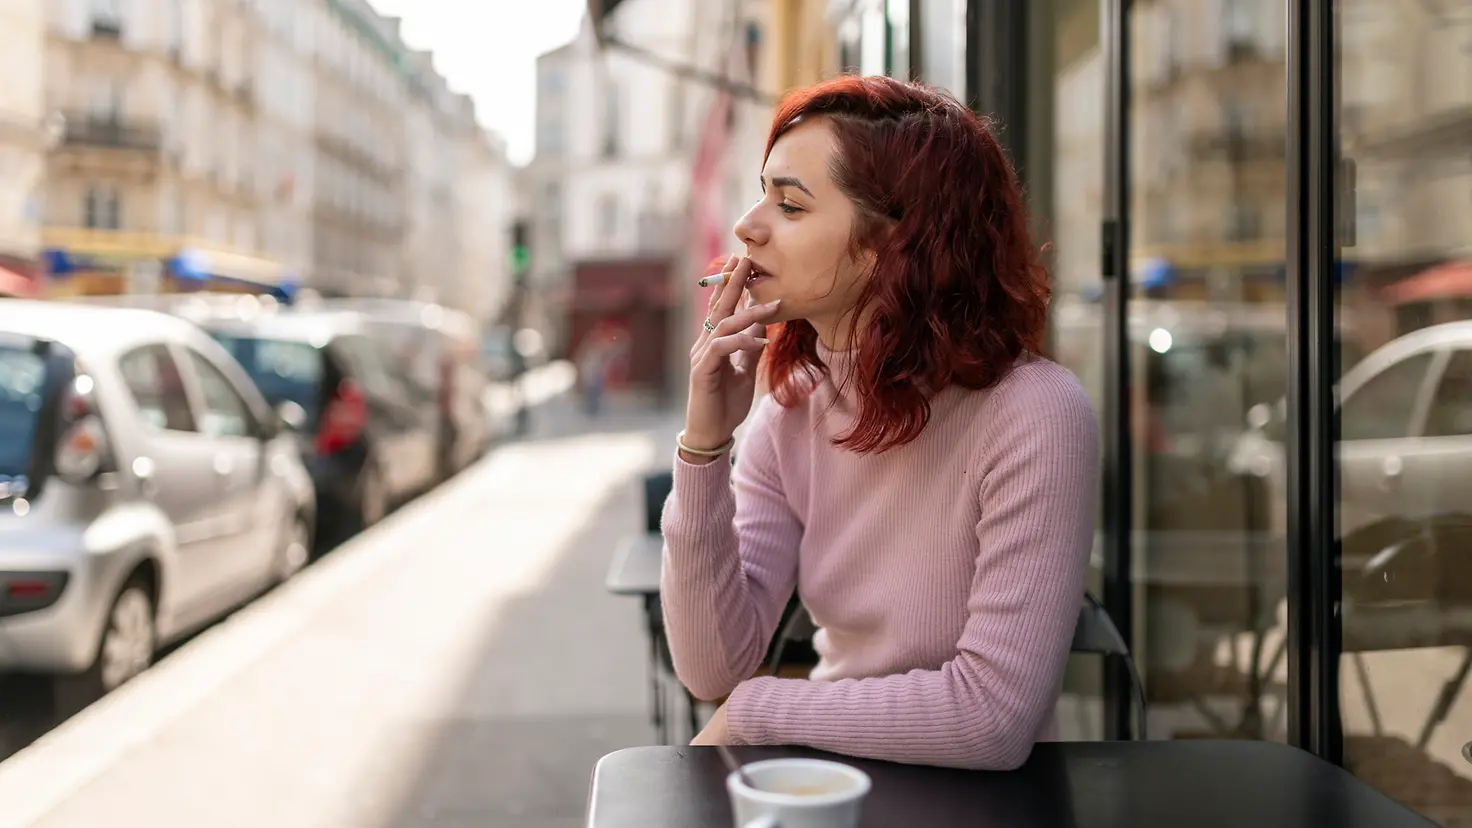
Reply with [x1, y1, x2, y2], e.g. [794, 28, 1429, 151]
[526, 0, 770, 380]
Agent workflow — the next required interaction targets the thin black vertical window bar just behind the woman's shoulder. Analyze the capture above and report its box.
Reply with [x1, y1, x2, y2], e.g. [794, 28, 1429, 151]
[1100, 0, 1135, 740]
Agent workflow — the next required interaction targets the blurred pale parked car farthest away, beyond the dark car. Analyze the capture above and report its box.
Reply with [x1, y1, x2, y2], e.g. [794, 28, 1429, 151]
[310, 299, 495, 480]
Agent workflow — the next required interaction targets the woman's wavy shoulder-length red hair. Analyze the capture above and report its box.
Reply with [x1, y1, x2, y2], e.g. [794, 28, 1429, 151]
[764, 75, 1051, 452]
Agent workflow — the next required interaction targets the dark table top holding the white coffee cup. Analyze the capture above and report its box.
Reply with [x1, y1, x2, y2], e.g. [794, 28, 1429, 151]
[587, 741, 1434, 828]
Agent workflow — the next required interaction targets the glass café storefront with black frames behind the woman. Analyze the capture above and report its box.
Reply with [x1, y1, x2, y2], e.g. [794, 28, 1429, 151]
[835, 0, 1472, 825]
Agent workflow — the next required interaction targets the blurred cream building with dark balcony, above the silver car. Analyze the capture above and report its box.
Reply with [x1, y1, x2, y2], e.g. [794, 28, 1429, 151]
[43, 0, 284, 295]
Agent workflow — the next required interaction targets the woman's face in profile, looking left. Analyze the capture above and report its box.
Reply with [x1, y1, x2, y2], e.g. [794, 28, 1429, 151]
[735, 118, 873, 348]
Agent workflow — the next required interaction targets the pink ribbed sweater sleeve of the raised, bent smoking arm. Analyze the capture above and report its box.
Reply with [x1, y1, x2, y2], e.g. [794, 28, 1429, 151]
[659, 398, 802, 700]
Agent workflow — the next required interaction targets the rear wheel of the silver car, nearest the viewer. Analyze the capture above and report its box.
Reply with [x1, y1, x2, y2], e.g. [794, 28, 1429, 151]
[56, 578, 158, 715]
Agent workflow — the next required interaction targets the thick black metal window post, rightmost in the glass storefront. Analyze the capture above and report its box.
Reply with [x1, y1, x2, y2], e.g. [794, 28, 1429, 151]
[1285, 0, 1342, 763]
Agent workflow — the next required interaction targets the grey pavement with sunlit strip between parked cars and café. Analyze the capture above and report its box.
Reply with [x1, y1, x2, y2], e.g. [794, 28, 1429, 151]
[0, 388, 677, 828]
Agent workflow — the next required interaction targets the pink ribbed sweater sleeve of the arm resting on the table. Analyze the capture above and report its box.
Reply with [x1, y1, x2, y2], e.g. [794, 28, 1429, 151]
[727, 364, 1100, 771]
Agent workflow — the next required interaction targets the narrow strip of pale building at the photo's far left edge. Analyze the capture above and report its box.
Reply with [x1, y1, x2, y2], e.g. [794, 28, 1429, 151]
[0, 0, 49, 296]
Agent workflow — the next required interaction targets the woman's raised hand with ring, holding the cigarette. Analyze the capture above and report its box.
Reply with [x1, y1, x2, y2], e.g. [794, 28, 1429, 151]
[680, 255, 780, 463]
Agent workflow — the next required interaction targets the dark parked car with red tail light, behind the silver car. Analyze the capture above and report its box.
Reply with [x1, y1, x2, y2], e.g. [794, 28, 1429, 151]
[190, 308, 440, 530]
